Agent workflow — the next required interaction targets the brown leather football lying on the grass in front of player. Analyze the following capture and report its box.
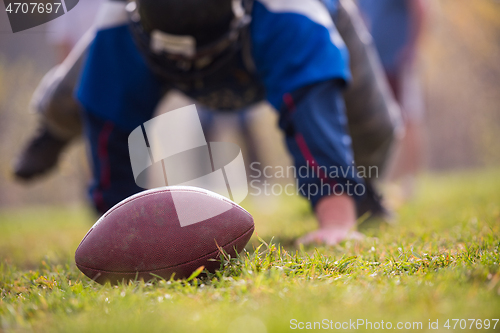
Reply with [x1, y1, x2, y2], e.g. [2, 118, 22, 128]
[75, 186, 254, 284]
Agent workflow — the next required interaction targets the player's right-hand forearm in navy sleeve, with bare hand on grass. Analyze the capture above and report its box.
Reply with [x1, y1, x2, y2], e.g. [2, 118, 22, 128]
[280, 80, 365, 244]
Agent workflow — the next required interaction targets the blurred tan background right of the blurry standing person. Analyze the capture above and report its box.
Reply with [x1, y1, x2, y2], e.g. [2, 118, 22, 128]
[420, 0, 500, 170]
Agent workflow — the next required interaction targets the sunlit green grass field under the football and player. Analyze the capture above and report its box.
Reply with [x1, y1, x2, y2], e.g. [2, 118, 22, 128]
[0, 170, 500, 333]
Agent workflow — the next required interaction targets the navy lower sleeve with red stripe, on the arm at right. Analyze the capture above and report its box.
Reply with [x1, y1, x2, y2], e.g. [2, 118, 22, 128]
[279, 81, 365, 207]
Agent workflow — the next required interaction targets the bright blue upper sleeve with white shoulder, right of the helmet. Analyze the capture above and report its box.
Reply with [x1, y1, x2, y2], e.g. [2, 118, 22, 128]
[251, 0, 350, 110]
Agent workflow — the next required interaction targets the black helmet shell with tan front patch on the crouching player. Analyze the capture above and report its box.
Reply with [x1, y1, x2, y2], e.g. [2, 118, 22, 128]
[126, 0, 253, 80]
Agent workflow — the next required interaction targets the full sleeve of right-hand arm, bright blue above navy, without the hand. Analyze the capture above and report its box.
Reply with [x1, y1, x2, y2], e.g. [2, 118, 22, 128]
[252, 0, 357, 206]
